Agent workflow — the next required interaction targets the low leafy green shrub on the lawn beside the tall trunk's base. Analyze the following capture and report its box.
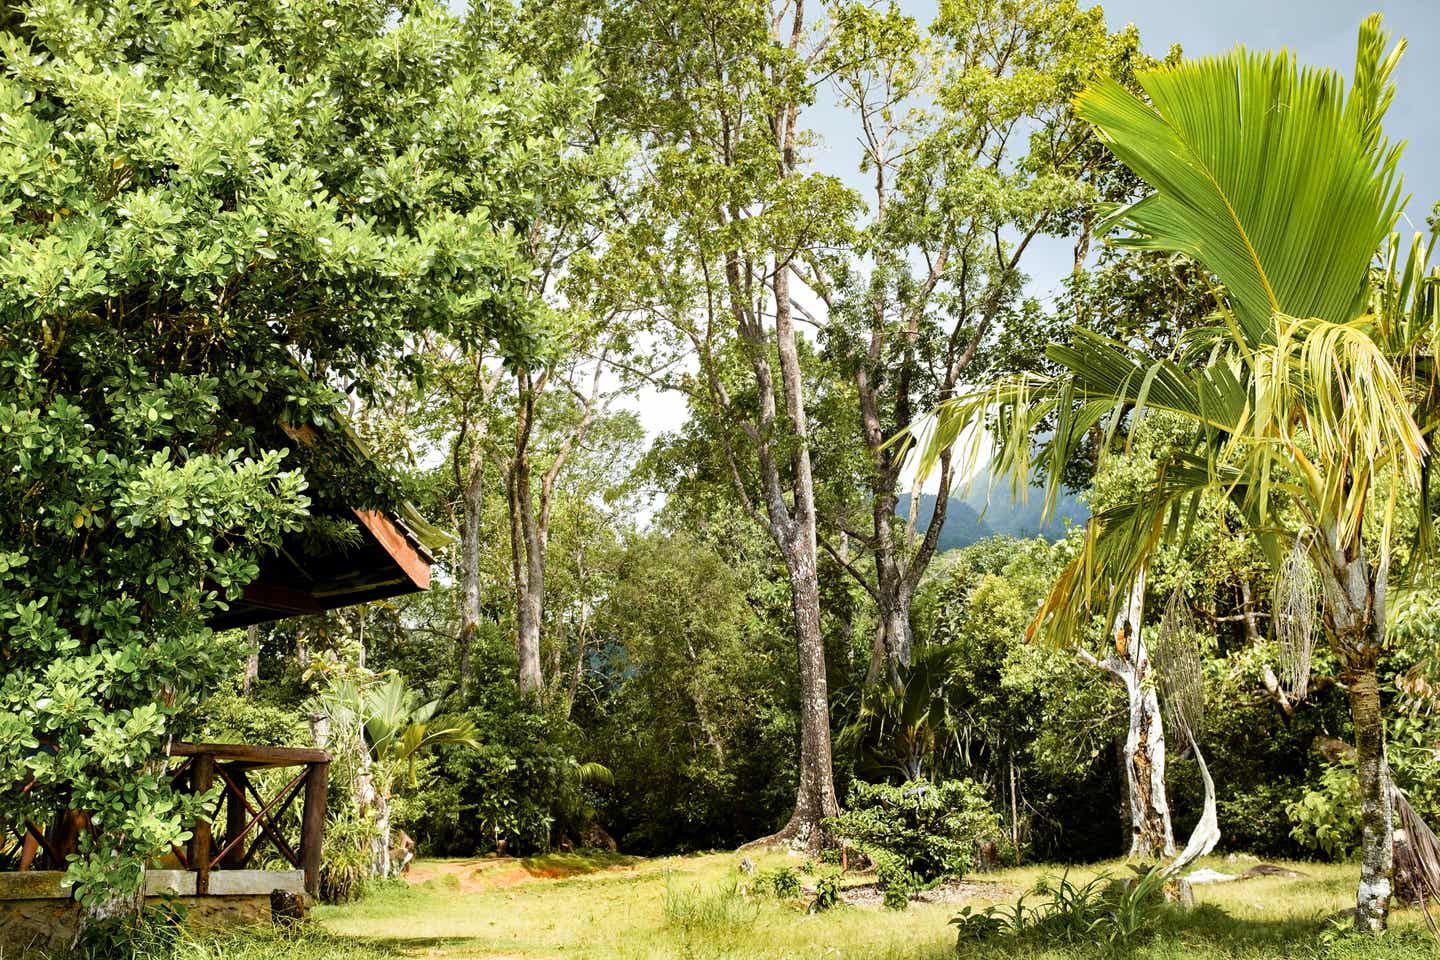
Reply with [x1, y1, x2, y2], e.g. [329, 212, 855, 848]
[829, 780, 1001, 885]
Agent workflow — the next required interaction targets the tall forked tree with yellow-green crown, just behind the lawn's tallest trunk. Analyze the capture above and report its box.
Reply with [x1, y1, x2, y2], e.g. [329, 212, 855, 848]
[802, 0, 1143, 688]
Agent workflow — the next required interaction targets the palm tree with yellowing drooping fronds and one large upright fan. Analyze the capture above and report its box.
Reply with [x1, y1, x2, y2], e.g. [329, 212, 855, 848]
[914, 16, 1437, 930]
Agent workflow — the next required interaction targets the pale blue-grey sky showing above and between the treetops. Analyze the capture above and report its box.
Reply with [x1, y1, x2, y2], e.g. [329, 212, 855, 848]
[626, 0, 1440, 454]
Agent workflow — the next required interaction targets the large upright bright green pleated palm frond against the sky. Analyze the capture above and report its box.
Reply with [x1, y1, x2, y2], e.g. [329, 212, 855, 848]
[1076, 20, 1401, 345]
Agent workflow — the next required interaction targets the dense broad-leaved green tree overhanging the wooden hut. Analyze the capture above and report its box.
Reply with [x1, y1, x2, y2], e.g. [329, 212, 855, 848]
[0, 0, 539, 907]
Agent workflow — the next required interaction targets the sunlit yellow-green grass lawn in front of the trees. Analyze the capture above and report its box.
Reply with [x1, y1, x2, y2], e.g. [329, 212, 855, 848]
[180, 853, 1440, 960]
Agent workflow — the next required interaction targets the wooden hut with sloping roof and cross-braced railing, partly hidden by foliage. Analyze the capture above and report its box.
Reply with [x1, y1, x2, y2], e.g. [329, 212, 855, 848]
[0, 427, 449, 953]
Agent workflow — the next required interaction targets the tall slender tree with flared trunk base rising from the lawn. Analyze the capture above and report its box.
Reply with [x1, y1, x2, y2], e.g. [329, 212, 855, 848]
[598, 0, 854, 846]
